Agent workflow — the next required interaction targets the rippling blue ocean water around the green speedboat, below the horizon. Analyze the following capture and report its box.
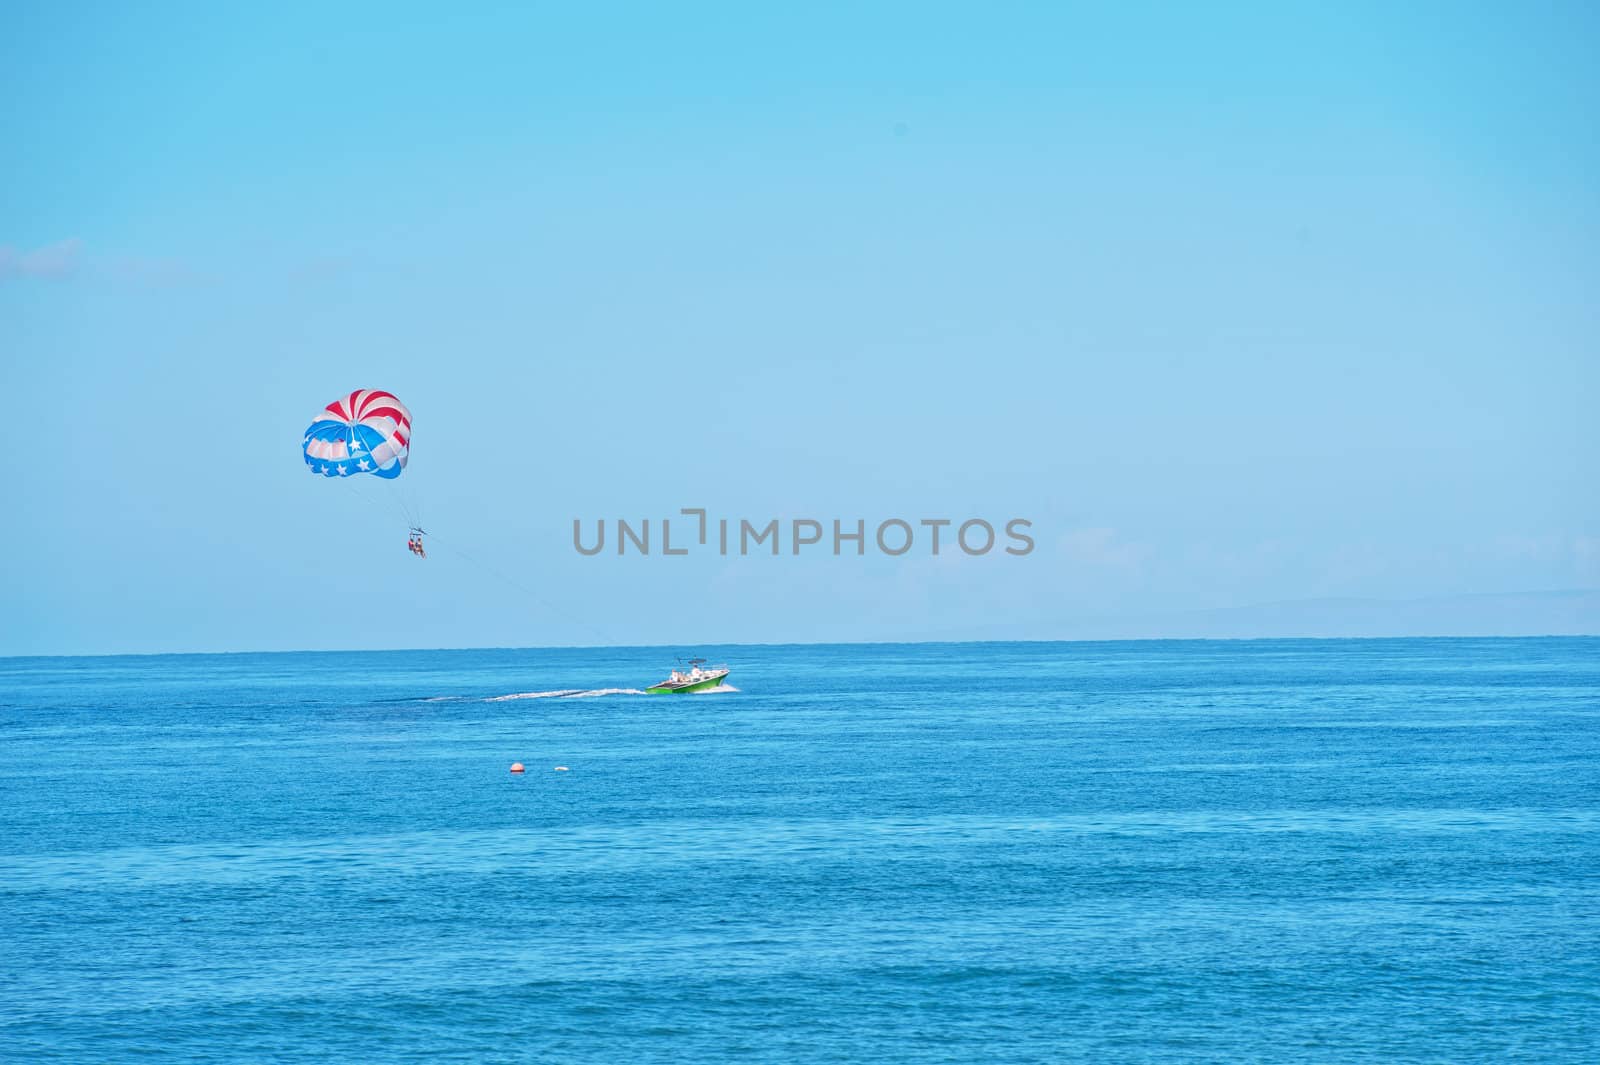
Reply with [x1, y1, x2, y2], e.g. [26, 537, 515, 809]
[0, 638, 1600, 1065]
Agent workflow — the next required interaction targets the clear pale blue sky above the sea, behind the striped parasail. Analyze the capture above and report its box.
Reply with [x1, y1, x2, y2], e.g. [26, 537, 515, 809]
[0, 3, 1600, 654]
